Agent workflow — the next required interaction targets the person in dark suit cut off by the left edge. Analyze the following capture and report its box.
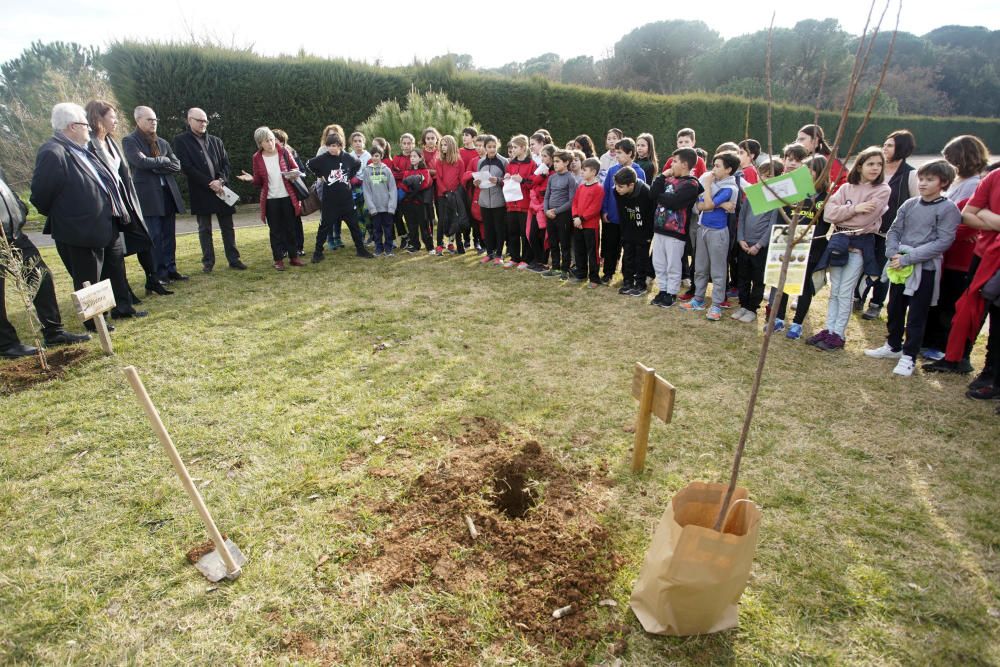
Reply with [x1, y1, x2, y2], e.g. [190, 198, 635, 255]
[0, 166, 90, 359]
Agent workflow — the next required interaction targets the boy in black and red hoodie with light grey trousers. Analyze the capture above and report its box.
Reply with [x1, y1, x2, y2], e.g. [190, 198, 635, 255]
[650, 148, 703, 308]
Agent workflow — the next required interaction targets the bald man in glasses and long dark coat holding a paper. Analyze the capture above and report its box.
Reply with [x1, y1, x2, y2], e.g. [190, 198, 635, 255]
[174, 108, 247, 273]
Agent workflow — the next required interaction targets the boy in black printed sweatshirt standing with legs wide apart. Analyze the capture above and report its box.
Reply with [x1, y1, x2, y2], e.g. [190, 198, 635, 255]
[308, 132, 375, 264]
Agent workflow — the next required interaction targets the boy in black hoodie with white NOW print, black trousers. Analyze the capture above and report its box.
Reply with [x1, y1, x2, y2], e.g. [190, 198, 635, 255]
[613, 167, 653, 296]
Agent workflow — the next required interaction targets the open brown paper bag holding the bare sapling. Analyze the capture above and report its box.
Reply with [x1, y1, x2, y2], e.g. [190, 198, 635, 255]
[629, 482, 761, 636]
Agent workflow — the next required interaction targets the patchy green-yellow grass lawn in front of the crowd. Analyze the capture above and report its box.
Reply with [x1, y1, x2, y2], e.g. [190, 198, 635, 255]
[0, 223, 1000, 665]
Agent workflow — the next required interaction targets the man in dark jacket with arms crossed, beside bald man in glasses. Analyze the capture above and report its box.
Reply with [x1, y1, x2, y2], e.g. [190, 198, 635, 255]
[122, 107, 187, 282]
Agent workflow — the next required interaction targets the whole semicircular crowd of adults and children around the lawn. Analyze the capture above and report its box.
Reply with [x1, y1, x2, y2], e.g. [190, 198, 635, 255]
[0, 101, 1000, 414]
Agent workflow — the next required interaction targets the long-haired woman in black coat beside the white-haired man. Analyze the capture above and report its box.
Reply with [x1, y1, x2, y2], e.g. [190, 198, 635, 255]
[84, 100, 173, 302]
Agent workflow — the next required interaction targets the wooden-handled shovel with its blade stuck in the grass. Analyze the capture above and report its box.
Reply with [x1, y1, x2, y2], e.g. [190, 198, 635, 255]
[124, 366, 247, 582]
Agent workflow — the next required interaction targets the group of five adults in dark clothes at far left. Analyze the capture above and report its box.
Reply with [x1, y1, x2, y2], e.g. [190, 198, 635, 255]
[0, 100, 247, 358]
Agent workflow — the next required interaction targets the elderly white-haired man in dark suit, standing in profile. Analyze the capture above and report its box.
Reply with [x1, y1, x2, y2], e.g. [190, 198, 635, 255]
[31, 102, 146, 330]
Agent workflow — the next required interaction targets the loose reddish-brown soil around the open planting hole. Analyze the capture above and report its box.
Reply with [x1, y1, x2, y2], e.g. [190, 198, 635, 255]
[354, 418, 620, 664]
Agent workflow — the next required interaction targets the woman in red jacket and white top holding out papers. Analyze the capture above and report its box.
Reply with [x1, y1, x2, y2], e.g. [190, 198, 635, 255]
[237, 126, 305, 271]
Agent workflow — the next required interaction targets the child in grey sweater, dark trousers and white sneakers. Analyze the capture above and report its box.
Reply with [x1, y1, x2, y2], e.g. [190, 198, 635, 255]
[865, 160, 962, 377]
